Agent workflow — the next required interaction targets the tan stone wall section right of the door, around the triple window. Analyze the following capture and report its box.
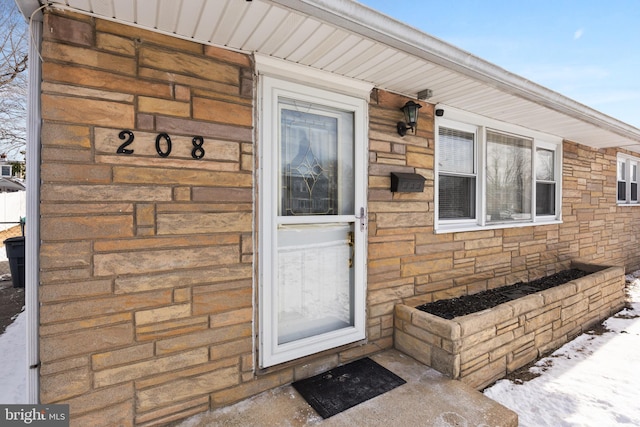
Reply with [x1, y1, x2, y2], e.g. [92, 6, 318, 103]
[368, 90, 640, 314]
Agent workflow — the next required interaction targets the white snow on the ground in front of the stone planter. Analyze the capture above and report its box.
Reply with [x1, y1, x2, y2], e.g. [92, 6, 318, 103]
[484, 272, 640, 427]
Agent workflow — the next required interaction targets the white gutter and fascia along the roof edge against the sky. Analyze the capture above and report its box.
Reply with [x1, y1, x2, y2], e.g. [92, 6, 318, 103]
[270, 0, 640, 141]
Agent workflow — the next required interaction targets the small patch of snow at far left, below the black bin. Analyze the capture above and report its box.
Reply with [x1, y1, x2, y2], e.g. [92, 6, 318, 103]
[0, 311, 27, 404]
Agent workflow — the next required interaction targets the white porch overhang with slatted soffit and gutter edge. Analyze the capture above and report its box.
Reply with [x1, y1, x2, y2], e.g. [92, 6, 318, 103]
[16, 0, 640, 153]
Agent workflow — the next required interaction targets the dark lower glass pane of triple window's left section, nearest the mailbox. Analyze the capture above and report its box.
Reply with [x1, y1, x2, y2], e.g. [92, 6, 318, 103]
[438, 175, 476, 219]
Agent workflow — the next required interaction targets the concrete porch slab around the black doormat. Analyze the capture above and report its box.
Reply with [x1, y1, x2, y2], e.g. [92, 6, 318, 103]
[178, 350, 518, 427]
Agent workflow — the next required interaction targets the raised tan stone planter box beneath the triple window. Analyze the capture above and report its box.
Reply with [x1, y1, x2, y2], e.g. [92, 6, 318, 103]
[394, 263, 625, 389]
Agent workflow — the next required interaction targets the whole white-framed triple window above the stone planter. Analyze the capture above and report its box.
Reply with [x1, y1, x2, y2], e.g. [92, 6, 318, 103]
[435, 106, 562, 233]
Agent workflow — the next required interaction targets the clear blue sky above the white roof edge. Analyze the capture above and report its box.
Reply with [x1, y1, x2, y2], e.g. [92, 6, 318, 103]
[358, 0, 640, 128]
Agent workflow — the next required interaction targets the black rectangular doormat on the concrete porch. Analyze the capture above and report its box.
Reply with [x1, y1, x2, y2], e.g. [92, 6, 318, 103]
[292, 357, 406, 418]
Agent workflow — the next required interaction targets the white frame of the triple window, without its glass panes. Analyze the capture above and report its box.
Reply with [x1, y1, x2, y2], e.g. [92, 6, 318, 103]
[434, 105, 562, 234]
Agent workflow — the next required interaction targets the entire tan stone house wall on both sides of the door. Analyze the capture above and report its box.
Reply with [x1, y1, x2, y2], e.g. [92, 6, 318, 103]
[40, 6, 640, 426]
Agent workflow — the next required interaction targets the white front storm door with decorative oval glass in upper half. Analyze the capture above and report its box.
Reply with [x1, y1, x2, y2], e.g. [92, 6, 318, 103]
[260, 77, 366, 367]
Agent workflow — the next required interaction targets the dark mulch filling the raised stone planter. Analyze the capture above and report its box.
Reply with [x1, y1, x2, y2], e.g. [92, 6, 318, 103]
[416, 269, 589, 319]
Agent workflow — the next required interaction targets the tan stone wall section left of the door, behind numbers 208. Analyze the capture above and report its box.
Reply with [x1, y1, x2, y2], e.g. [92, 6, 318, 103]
[40, 12, 256, 426]
